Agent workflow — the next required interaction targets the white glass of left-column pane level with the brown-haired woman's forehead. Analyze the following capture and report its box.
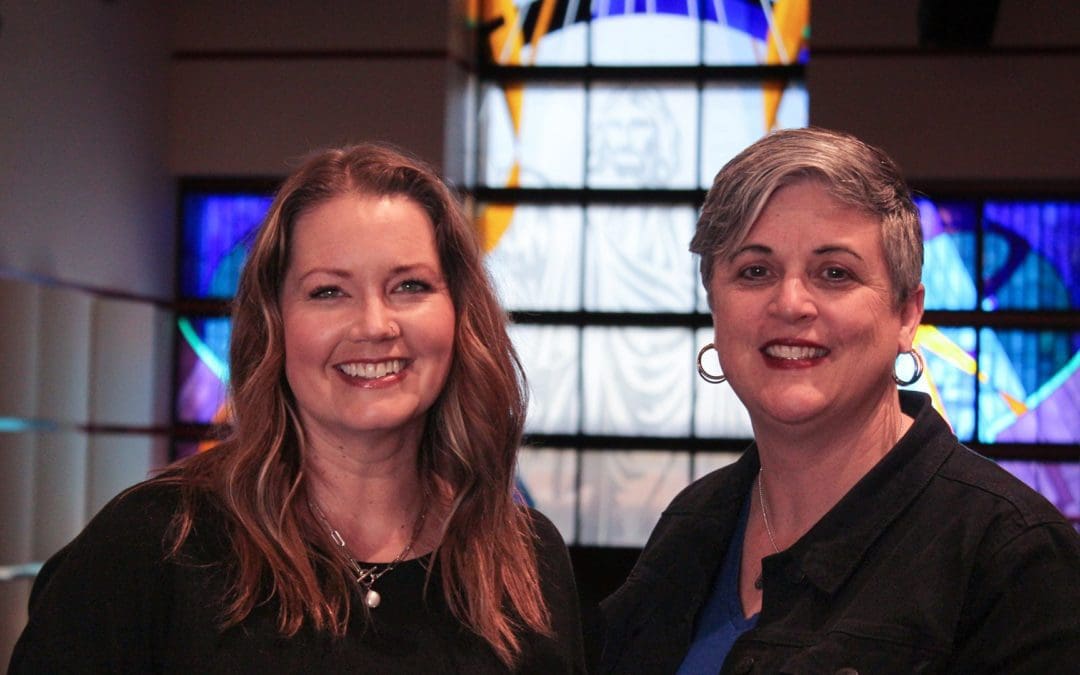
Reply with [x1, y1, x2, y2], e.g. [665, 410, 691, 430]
[485, 205, 583, 310]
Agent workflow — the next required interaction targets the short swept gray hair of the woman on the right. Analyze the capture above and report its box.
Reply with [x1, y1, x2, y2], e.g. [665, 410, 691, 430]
[690, 127, 922, 306]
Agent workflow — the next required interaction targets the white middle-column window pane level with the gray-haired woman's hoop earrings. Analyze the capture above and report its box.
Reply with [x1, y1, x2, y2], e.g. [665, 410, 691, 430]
[583, 327, 696, 436]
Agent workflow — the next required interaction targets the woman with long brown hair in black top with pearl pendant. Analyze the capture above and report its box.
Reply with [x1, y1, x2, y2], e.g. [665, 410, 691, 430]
[11, 145, 583, 673]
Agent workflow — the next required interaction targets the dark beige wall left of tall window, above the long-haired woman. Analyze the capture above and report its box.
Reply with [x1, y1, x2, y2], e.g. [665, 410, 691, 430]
[168, 0, 468, 176]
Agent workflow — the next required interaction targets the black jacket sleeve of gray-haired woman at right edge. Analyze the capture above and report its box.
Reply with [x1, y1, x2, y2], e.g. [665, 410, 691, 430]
[953, 522, 1080, 673]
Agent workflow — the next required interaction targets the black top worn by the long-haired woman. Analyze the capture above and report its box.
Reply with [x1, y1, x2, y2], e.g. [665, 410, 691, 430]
[10, 484, 584, 675]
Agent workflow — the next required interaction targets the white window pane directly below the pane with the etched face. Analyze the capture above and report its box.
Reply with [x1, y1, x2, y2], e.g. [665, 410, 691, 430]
[585, 206, 696, 312]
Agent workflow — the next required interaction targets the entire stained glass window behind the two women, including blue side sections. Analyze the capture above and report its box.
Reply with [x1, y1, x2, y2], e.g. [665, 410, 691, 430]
[175, 0, 1080, 546]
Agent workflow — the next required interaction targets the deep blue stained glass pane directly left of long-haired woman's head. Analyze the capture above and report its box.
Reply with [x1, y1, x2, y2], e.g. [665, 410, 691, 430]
[179, 193, 272, 298]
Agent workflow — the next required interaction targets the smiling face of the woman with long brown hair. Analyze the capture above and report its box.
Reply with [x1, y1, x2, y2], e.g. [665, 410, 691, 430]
[281, 194, 455, 447]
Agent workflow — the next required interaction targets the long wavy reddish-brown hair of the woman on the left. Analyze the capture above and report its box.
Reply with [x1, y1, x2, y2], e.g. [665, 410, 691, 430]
[159, 144, 551, 665]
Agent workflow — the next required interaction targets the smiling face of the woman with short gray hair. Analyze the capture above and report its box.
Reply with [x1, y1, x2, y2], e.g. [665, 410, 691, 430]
[710, 178, 922, 430]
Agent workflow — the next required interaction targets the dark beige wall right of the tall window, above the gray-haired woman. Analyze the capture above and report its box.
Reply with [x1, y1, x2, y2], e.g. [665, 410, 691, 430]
[808, 0, 1080, 182]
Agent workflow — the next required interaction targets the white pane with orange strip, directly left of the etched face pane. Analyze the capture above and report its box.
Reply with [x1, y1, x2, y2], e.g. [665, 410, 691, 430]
[477, 85, 585, 188]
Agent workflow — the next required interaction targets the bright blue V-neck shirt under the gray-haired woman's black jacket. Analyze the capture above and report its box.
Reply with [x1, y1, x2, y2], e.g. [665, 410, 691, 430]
[678, 496, 758, 675]
